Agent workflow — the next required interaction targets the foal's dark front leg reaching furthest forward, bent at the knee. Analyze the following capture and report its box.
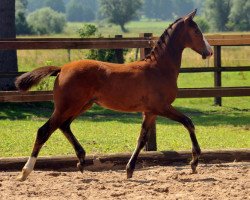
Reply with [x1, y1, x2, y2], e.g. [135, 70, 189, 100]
[159, 106, 201, 173]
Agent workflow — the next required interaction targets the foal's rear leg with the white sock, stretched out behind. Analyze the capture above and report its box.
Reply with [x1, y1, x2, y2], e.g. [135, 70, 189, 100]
[17, 116, 58, 181]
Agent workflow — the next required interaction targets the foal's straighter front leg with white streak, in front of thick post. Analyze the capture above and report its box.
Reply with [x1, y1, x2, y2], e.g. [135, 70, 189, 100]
[126, 113, 156, 178]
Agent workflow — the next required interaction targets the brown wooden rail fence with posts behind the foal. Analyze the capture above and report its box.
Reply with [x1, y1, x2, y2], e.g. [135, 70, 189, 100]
[0, 33, 250, 150]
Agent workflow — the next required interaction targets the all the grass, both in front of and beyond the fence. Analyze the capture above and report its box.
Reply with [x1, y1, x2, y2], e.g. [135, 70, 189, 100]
[0, 22, 250, 157]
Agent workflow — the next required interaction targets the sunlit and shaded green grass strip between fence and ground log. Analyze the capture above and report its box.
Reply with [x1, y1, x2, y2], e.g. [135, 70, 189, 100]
[0, 97, 250, 157]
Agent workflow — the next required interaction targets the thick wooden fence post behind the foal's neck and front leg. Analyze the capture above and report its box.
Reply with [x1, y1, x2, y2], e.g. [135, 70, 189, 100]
[139, 33, 157, 151]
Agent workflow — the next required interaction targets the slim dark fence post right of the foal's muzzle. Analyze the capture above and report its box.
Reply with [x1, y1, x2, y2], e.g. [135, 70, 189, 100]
[214, 46, 222, 106]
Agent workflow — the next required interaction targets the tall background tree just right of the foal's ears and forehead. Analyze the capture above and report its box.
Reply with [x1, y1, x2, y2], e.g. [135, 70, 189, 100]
[204, 0, 232, 31]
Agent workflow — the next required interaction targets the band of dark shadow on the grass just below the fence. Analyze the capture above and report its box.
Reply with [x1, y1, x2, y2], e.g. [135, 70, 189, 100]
[0, 102, 250, 127]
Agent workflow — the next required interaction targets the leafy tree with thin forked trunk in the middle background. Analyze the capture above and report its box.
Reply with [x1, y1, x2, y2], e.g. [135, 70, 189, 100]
[100, 0, 142, 32]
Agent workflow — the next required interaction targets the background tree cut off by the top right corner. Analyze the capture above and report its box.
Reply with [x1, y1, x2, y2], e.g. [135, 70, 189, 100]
[227, 0, 250, 31]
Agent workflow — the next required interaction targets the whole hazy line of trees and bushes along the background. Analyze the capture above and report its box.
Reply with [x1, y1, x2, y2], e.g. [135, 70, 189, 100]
[16, 0, 250, 34]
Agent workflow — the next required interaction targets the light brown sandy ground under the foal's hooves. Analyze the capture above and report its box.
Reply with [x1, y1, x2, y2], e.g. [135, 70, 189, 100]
[0, 162, 250, 200]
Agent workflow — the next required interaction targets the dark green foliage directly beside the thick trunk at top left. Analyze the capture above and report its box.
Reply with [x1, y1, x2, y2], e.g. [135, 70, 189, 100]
[15, 0, 31, 35]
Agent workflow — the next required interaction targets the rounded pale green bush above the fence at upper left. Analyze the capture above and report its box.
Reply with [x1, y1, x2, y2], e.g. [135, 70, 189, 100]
[27, 7, 66, 35]
